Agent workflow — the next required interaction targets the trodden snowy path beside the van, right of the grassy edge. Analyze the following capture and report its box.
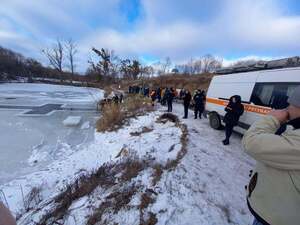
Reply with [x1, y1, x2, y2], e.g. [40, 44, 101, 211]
[153, 105, 254, 225]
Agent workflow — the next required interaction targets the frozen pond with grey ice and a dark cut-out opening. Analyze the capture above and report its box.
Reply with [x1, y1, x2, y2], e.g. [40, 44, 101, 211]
[0, 84, 103, 184]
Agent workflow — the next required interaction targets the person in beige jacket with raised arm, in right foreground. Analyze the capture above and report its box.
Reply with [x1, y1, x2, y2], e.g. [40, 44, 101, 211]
[242, 86, 300, 225]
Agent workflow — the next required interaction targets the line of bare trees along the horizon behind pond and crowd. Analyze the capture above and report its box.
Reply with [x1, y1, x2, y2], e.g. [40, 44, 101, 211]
[0, 39, 226, 82]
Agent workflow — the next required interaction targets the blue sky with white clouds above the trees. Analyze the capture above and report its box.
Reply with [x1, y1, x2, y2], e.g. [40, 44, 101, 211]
[0, 0, 300, 71]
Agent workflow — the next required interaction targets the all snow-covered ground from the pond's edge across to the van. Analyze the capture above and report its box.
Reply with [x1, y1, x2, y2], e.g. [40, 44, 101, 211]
[0, 93, 254, 225]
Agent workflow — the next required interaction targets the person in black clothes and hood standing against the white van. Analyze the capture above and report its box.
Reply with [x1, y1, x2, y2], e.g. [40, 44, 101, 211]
[223, 95, 244, 145]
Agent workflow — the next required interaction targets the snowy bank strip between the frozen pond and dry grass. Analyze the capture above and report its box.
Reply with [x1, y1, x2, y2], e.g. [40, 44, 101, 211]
[1, 110, 181, 221]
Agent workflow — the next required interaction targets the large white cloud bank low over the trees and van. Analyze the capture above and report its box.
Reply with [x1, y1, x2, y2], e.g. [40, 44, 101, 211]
[84, 0, 300, 61]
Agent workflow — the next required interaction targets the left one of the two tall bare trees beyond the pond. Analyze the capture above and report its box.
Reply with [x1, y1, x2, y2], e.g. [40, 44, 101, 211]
[42, 39, 64, 80]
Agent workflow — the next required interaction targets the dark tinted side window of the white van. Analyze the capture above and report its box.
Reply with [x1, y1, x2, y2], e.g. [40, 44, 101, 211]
[250, 83, 300, 109]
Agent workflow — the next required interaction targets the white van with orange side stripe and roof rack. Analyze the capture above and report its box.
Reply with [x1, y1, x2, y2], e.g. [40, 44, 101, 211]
[205, 67, 300, 133]
